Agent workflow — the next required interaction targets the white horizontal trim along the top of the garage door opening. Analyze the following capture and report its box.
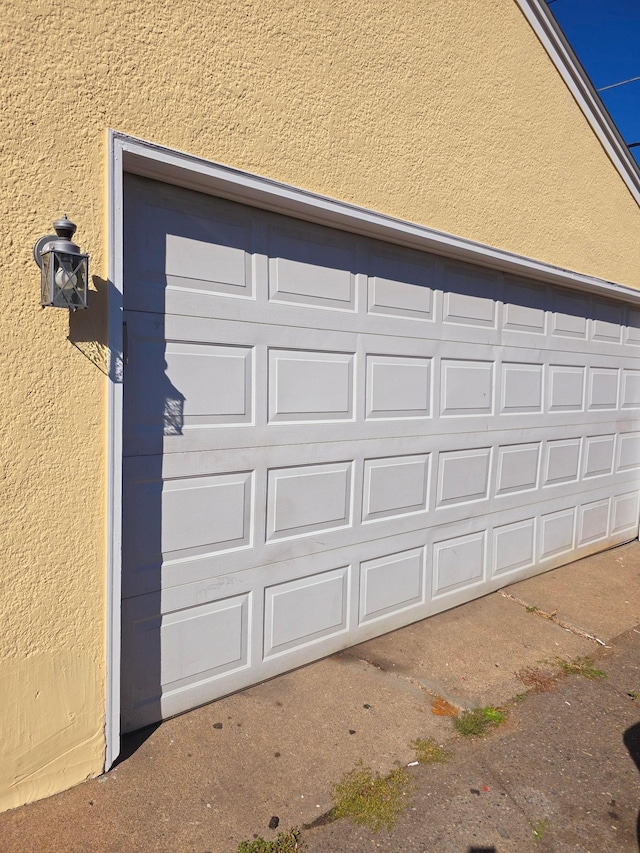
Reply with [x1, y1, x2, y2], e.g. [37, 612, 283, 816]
[112, 131, 640, 304]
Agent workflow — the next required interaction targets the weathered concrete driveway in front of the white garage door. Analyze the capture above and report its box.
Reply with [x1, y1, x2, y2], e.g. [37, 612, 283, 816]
[0, 542, 640, 853]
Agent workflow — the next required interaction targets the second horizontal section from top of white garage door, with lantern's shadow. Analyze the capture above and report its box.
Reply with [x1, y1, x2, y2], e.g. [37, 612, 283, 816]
[127, 314, 638, 460]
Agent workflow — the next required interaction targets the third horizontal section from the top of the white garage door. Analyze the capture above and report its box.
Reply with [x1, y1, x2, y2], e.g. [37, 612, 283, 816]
[124, 430, 637, 595]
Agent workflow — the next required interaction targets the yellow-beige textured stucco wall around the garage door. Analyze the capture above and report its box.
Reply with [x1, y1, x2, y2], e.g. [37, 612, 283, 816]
[0, 0, 640, 808]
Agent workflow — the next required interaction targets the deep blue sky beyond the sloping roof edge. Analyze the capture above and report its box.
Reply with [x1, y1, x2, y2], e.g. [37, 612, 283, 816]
[547, 0, 640, 164]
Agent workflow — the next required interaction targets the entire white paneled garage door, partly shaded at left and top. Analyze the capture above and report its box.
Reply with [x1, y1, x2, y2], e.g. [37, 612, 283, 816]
[122, 177, 640, 730]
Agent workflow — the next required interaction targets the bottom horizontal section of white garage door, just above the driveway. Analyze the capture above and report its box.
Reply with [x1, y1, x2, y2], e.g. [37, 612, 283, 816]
[120, 480, 638, 728]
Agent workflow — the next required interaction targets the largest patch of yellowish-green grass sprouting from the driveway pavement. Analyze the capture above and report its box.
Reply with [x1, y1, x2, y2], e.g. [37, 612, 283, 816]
[331, 764, 409, 832]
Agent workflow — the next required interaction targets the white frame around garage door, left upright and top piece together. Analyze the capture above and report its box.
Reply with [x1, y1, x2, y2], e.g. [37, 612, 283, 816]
[105, 131, 640, 770]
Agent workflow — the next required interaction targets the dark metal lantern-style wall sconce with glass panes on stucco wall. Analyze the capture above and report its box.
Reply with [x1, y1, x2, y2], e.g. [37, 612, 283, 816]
[33, 213, 89, 311]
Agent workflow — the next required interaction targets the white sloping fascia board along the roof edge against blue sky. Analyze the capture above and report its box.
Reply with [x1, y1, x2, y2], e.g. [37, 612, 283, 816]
[516, 0, 640, 210]
